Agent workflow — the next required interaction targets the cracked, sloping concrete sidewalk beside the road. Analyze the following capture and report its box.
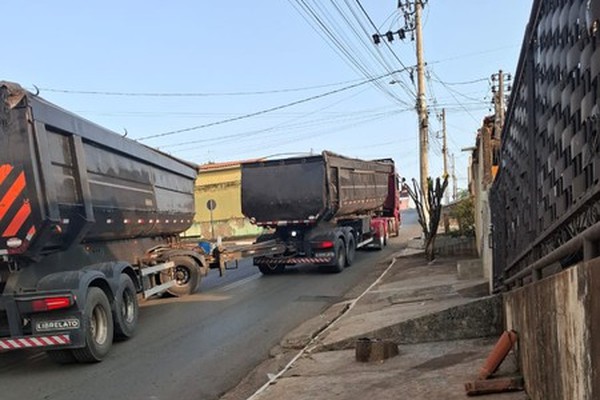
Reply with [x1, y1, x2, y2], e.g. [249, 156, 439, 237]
[223, 236, 527, 400]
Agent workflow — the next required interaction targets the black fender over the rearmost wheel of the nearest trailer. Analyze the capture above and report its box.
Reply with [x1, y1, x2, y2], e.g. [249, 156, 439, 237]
[36, 270, 114, 309]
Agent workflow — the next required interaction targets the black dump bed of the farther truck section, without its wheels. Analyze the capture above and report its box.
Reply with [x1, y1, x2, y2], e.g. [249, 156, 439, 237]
[242, 151, 394, 224]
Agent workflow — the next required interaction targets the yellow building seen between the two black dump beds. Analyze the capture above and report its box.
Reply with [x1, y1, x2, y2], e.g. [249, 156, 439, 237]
[184, 161, 262, 239]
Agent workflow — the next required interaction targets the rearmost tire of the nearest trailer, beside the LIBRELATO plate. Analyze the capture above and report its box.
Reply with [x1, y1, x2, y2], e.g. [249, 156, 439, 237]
[72, 287, 113, 363]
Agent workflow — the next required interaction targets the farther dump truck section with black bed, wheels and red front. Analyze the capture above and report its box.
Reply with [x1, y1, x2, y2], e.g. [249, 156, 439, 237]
[242, 151, 400, 274]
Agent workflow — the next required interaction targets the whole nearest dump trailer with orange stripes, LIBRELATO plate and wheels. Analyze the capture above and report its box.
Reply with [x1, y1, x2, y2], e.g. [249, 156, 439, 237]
[0, 82, 216, 363]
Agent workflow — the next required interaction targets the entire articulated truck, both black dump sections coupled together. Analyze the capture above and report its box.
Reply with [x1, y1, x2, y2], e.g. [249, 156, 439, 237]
[0, 81, 399, 363]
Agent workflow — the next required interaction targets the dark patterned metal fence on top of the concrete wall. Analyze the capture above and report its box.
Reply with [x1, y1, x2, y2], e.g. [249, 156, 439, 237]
[490, 0, 600, 287]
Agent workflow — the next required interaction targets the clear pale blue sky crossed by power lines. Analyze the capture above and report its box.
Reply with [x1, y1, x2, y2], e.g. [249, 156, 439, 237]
[0, 0, 532, 188]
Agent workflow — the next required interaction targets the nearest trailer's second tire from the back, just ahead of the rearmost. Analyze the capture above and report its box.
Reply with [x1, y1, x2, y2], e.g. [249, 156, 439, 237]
[113, 274, 139, 339]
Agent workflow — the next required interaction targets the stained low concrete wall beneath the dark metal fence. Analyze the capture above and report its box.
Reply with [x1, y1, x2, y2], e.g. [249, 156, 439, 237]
[504, 259, 600, 400]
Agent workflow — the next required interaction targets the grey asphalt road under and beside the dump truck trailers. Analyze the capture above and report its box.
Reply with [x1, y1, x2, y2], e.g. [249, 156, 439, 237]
[0, 209, 412, 400]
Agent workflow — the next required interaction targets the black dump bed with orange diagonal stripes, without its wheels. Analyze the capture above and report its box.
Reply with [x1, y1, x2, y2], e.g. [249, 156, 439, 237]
[0, 82, 196, 258]
